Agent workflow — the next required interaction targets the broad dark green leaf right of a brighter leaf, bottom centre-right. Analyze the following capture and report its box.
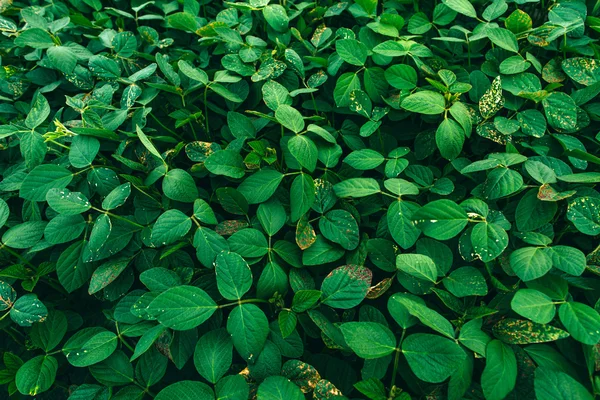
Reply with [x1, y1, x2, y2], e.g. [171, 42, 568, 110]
[402, 333, 466, 383]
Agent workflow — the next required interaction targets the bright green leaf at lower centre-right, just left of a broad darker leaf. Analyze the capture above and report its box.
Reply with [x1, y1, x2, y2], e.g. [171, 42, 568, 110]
[340, 322, 396, 359]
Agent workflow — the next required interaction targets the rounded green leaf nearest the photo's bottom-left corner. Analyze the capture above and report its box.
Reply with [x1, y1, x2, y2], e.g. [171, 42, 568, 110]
[15, 356, 58, 396]
